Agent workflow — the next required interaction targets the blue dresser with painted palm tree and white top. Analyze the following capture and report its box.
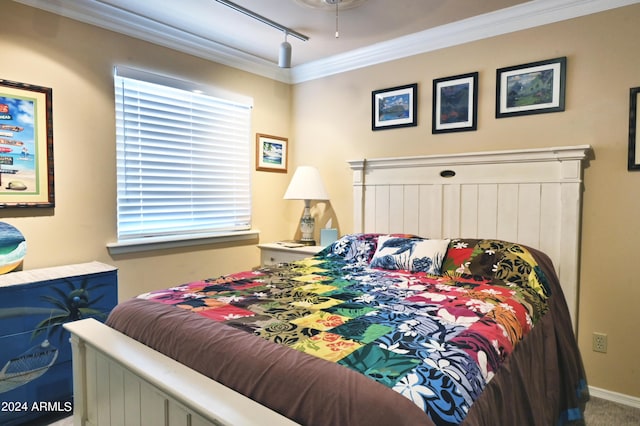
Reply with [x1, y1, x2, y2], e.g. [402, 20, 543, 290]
[0, 262, 118, 425]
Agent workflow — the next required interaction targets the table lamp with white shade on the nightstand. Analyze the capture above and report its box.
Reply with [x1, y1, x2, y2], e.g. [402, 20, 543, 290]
[284, 166, 329, 246]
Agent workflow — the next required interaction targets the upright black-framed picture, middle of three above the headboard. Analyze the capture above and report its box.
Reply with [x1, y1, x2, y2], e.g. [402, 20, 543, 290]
[431, 72, 478, 134]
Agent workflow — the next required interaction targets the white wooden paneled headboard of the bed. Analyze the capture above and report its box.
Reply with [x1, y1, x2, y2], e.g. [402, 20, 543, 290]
[349, 145, 591, 330]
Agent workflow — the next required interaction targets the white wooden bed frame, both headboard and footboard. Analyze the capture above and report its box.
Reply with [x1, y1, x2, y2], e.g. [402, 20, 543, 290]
[65, 145, 590, 426]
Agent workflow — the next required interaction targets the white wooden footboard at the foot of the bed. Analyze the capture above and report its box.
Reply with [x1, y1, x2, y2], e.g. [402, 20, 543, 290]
[65, 319, 295, 426]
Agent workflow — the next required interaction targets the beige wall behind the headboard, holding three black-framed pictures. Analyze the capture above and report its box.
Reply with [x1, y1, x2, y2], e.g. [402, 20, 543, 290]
[292, 5, 640, 397]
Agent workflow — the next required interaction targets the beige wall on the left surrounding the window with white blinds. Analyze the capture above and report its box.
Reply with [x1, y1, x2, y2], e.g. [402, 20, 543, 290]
[0, 2, 296, 299]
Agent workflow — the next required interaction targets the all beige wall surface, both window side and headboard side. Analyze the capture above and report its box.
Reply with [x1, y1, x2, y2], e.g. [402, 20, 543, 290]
[0, 2, 640, 397]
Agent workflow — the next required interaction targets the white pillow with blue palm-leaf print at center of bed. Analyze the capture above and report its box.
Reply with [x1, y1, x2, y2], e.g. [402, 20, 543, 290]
[370, 235, 449, 275]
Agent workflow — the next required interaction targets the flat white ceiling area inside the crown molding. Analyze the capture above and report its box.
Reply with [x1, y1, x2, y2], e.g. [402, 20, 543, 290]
[96, 0, 526, 66]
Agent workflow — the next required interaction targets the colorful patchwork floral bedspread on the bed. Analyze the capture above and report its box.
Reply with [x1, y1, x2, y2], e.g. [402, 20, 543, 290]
[140, 234, 548, 425]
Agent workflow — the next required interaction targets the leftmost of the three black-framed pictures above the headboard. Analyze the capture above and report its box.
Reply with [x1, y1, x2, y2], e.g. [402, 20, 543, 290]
[371, 83, 418, 130]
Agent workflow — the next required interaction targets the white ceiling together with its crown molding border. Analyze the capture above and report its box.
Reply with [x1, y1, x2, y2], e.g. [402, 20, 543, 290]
[15, 0, 640, 83]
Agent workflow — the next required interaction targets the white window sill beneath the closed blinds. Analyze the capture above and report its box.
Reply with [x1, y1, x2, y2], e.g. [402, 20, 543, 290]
[107, 229, 260, 255]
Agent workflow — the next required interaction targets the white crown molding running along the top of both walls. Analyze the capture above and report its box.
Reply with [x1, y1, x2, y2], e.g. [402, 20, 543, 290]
[14, 0, 640, 84]
